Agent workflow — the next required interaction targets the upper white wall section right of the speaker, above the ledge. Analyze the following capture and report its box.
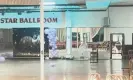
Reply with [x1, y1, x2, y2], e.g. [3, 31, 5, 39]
[109, 7, 133, 27]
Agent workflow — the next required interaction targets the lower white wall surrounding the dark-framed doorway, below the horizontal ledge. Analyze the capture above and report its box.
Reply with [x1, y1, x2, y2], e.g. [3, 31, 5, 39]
[104, 28, 133, 45]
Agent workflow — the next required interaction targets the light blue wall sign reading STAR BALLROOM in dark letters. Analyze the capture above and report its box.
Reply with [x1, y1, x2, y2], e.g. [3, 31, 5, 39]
[0, 12, 65, 28]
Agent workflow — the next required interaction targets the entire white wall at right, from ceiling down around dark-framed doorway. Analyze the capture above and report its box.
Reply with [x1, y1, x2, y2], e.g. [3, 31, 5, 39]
[104, 7, 133, 45]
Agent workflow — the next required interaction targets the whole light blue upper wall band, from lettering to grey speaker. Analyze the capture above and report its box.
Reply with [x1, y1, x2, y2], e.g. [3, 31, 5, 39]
[0, 11, 107, 28]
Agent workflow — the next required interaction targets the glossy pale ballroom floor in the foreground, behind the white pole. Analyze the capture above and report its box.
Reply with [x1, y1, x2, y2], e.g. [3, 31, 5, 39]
[0, 60, 129, 80]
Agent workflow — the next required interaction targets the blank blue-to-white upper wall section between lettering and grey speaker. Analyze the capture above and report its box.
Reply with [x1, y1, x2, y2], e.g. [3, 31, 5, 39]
[71, 11, 107, 27]
